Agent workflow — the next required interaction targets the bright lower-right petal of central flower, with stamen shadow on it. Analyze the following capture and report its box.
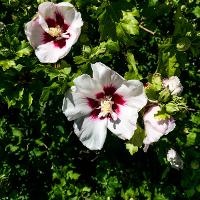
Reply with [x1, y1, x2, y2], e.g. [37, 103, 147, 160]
[108, 106, 138, 140]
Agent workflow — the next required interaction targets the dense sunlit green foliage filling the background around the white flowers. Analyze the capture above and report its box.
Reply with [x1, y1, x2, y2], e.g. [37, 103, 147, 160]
[0, 0, 200, 200]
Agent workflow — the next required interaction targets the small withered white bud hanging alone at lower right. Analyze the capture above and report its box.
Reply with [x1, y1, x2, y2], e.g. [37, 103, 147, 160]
[167, 149, 183, 169]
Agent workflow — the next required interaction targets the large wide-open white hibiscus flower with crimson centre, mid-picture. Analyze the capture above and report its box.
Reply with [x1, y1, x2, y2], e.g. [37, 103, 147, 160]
[62, 63, 147, 150]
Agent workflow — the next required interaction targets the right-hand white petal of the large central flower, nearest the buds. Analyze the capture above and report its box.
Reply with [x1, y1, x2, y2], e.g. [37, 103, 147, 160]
[115, 80, 147, 111]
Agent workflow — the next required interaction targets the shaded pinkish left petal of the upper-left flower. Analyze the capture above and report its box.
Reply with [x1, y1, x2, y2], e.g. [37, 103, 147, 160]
[25, 17, 44, 48]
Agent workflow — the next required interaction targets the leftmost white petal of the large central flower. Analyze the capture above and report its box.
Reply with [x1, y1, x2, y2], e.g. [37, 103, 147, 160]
[62, 92, 91, 121]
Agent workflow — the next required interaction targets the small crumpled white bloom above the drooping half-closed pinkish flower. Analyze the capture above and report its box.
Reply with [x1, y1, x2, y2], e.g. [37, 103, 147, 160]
[163, 76, 183, 95]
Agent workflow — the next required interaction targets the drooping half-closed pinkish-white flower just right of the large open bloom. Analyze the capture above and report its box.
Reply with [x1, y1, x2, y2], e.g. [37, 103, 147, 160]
[143, 106, 176, 152]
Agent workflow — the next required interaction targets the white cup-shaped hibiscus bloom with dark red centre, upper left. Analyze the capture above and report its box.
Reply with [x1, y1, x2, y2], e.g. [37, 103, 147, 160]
[25, 2, 83, 63]
